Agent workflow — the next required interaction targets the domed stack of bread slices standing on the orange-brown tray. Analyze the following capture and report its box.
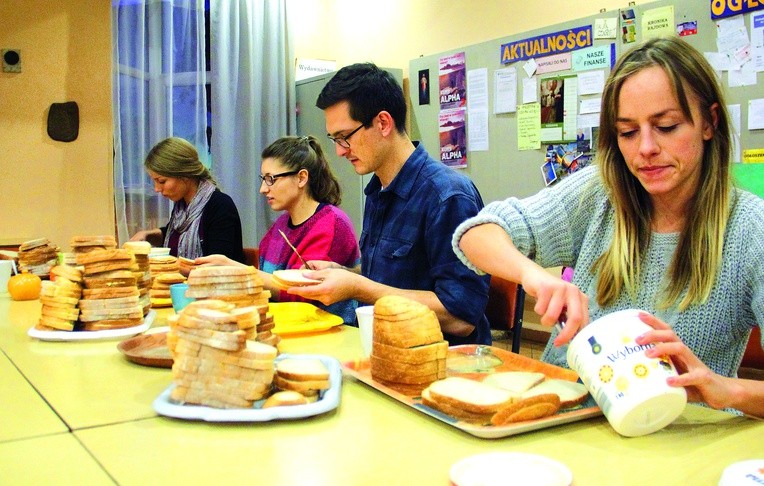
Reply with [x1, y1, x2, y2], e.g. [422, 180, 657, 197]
[369, 295, 448, 396]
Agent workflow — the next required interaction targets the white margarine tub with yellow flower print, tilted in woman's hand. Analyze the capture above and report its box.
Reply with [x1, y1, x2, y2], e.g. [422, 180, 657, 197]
[567, 309, 687, 437]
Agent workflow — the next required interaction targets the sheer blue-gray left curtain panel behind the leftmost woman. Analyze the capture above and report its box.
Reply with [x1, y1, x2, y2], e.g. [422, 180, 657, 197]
[112, 0, 209, 242]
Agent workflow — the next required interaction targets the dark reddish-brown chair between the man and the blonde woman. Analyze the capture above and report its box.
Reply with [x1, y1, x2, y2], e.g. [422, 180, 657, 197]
[485, 276, 525, 353]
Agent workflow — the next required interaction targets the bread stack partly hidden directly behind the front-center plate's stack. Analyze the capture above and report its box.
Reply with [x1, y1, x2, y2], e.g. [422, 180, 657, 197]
[186, 265, 281, 346]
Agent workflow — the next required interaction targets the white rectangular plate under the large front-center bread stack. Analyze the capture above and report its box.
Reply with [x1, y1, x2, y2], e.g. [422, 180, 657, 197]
[153, 354, 342, 422]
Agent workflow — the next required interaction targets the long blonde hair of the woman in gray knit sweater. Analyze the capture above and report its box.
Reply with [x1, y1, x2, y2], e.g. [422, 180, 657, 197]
[592, 37, 731, 310]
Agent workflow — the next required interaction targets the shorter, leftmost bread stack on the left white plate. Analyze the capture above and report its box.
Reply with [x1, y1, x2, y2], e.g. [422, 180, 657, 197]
[37, 265, 82, 331]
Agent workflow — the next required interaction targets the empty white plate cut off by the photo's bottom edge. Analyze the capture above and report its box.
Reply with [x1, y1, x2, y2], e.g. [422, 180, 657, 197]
[450, 452, 573, 486]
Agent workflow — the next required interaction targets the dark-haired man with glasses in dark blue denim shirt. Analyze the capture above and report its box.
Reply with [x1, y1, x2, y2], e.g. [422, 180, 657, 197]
[289, 63, 491, 345]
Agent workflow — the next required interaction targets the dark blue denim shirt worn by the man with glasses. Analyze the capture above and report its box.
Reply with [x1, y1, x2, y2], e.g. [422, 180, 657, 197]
[361, 145, 491, 345]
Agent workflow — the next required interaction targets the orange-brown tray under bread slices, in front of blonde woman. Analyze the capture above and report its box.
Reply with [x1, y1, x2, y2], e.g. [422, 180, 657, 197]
[342, 344, 602, 439]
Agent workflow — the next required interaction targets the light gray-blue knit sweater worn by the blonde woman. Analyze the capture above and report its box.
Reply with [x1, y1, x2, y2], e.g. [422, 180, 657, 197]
[453, 163, 764, 376]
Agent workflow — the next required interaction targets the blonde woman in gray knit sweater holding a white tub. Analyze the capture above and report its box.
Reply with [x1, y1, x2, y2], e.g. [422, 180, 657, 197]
[453, 37, 764, 416]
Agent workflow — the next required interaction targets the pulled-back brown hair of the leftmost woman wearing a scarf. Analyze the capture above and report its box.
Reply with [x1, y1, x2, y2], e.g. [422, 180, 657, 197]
[143, 137, 217, 185]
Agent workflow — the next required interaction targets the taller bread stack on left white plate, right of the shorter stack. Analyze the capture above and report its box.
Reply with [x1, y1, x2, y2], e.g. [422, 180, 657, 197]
[77, 249, 143, 331]
